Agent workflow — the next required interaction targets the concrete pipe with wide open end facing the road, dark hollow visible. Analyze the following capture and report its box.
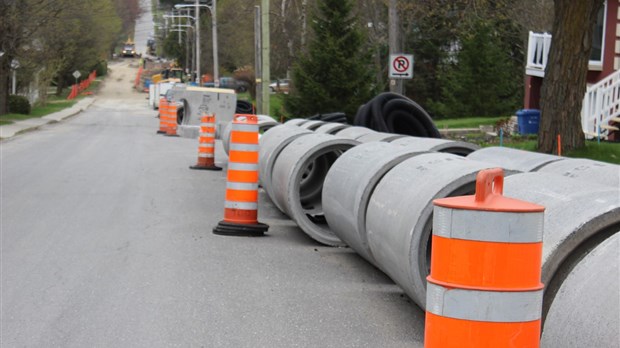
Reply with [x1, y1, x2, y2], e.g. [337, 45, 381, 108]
[270, 133, 359, 246]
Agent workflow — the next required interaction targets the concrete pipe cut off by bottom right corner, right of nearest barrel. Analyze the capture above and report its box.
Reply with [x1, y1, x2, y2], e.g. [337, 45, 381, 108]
[540, 233, 620, 348]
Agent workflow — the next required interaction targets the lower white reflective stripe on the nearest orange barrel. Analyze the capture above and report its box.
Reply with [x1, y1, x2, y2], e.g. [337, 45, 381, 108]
[426, 282, 543, 323]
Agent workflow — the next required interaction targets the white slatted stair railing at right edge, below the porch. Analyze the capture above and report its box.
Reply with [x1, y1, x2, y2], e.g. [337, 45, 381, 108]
[581, 70, 620, 138]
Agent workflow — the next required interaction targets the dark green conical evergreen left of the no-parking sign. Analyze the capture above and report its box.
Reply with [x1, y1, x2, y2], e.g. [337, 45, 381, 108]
[285, 0, 374, 119]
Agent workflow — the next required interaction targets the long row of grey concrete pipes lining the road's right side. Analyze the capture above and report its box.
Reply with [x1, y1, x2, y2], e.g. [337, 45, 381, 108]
[225, 120, 620, 346]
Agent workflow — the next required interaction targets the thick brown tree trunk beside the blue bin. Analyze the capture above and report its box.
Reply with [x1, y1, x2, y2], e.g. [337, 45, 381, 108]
[538, 0, 603, 154]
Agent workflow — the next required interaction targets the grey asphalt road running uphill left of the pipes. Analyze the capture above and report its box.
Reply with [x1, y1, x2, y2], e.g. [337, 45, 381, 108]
[0, 61, 424, 347]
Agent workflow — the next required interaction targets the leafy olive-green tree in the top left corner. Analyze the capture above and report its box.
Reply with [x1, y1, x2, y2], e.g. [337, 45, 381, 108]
[0, 0, 122, 115]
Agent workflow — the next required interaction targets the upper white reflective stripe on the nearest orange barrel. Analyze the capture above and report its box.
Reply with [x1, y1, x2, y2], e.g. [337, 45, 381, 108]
[433, 206, 544, 243]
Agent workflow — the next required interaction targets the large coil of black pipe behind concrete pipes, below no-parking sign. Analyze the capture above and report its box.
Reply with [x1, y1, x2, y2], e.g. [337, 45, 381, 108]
[354, 92, 441, 138]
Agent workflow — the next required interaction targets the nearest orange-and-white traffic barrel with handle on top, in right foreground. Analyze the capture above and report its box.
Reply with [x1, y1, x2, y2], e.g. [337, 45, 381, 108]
[424, 168, 545, 348]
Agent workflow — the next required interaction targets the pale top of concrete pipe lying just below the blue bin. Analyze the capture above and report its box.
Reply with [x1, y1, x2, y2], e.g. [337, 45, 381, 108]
[467, 147, 564, 172]
